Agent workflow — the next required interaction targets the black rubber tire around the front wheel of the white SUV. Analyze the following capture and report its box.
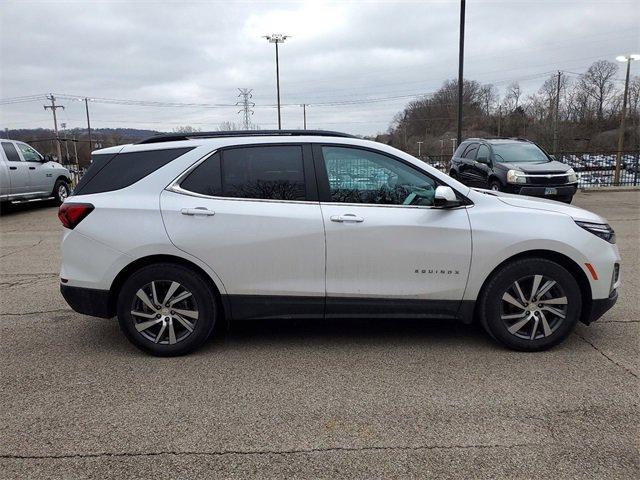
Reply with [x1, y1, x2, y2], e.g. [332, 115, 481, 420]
[478, 258, 582, 352]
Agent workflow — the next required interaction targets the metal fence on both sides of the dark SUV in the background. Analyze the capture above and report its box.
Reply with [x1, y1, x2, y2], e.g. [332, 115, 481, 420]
[422, 151, 640, 188]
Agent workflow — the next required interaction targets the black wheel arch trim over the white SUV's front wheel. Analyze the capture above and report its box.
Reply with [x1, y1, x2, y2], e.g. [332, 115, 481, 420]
[474, 250, 593, 324]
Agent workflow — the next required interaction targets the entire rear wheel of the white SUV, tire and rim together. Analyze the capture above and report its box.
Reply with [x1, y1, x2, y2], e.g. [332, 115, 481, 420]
[117, 264, 217, 356]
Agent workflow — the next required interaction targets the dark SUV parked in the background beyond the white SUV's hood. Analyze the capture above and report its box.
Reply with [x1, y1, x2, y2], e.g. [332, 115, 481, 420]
[449, 138, 578, 203]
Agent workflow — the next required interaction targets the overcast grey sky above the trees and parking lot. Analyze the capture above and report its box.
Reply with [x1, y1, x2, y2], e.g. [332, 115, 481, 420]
[0, 0, 640, 134]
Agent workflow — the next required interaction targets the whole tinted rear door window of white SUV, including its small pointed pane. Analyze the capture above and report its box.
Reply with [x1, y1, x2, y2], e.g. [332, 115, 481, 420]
[180, 145, 306, 200]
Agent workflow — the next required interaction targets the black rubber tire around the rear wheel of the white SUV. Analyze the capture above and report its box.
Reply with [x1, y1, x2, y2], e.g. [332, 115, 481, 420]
[117, 263, 218, 357]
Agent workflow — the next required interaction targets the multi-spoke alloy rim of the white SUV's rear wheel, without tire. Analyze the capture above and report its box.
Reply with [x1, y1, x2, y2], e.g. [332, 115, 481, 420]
[131, 280, 198, 345]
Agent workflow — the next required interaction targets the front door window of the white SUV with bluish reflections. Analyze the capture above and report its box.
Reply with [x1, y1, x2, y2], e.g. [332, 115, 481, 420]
[322, 146, 436, 206]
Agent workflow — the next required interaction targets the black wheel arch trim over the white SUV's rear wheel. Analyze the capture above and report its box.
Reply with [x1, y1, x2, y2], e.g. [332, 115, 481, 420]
[109, 254, 230, 321]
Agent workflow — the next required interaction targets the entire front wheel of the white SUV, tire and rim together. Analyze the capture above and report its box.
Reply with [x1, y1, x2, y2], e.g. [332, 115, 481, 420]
[479, 258, 582, 351]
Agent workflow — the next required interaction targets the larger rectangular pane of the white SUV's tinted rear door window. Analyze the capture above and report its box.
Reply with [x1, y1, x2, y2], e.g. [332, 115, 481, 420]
[221, 145, 306, 200]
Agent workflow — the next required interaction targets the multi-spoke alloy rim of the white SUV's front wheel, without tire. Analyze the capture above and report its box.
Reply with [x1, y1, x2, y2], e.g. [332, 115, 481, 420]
[500, 275, 568, 340]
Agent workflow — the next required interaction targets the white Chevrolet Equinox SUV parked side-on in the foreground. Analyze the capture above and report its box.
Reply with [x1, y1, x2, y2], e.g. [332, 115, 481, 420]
[59, 131, 620, 355]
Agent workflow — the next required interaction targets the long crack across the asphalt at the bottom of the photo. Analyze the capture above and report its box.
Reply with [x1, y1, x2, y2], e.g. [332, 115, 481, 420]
[0, 443, 539, 460]
